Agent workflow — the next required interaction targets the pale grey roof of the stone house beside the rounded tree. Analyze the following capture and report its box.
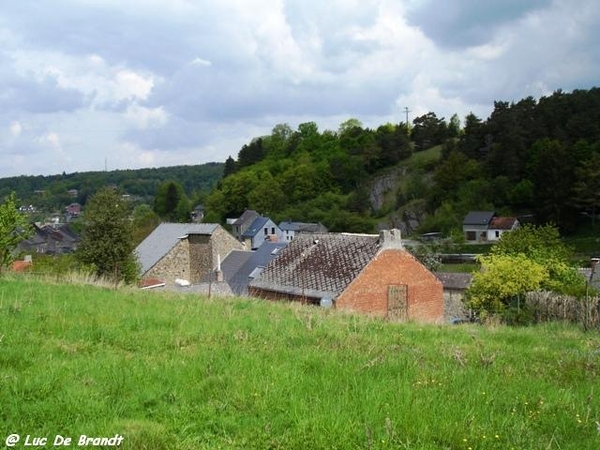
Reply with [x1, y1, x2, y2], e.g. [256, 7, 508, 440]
[135, 223, 219, 274]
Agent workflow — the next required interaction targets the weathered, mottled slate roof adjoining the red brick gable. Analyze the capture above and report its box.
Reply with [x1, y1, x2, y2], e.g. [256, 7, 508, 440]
[250, 233, 380, 298]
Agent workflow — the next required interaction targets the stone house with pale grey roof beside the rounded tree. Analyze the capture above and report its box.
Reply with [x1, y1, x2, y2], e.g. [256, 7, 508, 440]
[135, 223, 243, 286]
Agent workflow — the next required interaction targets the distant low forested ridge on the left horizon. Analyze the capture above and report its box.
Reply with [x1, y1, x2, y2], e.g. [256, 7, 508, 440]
[0, 163, 224, 210]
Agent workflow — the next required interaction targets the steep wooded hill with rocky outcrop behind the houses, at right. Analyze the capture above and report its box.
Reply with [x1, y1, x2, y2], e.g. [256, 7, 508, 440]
[206, 88, 600, 233]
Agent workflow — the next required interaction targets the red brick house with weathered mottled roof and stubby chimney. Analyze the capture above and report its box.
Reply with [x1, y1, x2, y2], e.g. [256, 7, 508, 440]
[249, 230, 444, 322]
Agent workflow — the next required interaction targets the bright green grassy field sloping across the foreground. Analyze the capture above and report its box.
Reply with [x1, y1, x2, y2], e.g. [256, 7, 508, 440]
[0, 279, 600, 450]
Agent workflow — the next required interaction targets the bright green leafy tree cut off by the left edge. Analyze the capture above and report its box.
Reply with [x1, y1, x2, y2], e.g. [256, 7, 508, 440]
[0, 192, 33, 273]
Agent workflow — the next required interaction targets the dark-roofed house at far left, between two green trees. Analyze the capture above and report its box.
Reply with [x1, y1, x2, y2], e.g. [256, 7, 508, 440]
[18, 223, 81, 255]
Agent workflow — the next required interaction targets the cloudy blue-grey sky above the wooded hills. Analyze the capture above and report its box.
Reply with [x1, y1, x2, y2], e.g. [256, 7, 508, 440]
[0, 0, 600, 177]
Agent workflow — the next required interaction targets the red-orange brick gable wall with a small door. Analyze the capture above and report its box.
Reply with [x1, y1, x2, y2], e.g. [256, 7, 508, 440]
[335, 249, 444, 322]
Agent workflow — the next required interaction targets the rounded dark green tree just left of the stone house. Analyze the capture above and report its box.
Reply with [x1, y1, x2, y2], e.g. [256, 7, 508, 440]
[76, 188, 139, 283]
